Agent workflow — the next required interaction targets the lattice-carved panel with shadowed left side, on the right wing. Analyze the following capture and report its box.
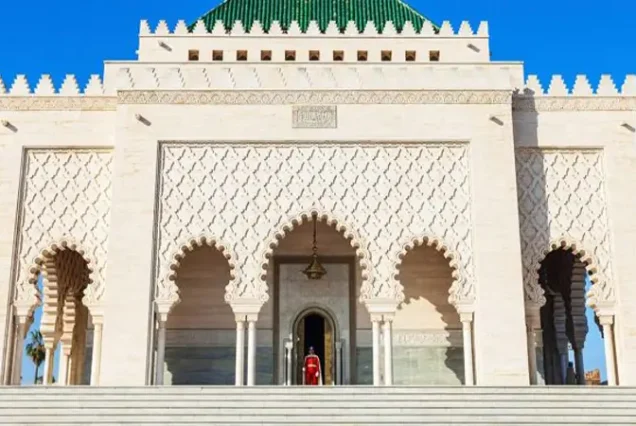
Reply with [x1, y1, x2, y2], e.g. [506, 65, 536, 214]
[515, 148, 615, 307]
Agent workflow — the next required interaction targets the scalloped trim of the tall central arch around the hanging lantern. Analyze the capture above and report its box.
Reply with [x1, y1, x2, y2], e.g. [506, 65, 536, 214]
[260, 209, 372, 302]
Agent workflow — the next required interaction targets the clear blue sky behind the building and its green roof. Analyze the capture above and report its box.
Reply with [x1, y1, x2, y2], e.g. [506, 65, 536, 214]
[7, 0, 636, 382]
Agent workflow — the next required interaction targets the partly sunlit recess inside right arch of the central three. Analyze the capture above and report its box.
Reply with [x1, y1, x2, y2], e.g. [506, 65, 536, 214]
[393, 236, 465, 385]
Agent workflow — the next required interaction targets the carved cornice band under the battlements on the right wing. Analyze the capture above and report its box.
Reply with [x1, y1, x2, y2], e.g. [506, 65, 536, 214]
[512, 95, 636, 112]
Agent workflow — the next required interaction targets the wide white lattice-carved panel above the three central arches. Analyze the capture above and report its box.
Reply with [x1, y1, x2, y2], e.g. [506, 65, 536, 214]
[157, 143, 474, 303]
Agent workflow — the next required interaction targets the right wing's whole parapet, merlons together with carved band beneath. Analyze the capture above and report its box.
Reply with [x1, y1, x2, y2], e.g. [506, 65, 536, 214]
[513, 75, 636, 111]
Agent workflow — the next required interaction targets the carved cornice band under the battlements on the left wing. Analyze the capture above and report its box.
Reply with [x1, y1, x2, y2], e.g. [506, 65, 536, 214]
[0, 95, 117, 111]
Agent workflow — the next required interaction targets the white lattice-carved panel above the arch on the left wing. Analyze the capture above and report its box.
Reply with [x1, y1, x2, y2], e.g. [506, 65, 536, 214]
[15, 149, 112, 305]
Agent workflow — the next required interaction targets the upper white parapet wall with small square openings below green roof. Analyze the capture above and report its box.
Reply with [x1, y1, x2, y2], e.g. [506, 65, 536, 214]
[138, 20, 490, 63]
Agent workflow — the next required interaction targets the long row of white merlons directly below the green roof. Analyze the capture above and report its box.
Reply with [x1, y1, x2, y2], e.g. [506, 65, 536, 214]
[139, 20, 488, 38]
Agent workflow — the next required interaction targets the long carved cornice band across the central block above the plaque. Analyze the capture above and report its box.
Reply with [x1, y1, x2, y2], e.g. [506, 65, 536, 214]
[117, 90, 512, 105]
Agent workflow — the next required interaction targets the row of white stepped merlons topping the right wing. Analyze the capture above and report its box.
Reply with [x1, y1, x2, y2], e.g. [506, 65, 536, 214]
[518, 74, 636, 97]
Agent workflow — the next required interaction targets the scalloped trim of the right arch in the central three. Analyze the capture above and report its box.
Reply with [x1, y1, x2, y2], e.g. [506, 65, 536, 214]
[393, 234, 474, 308]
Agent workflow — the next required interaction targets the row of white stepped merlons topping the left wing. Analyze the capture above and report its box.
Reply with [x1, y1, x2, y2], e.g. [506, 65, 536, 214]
[0, 74, 104, 96]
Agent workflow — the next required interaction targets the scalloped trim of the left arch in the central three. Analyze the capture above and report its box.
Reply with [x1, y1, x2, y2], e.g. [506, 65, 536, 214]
[155, 234, 240, 310]
